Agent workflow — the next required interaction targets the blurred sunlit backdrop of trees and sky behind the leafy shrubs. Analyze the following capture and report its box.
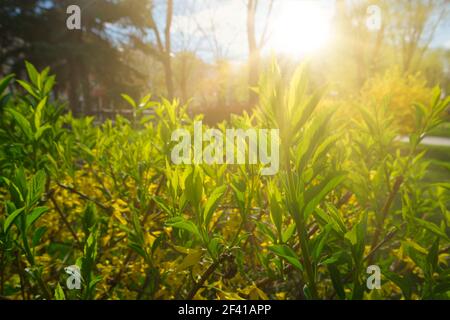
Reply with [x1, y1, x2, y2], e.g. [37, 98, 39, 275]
[0, 0, 450, 124]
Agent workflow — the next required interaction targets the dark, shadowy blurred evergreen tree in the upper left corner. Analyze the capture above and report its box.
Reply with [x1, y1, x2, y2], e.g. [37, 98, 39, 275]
[0, 0, 146, 114]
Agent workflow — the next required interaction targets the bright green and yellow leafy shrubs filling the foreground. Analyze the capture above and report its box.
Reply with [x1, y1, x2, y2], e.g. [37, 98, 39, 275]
[0, 63, 450, 299]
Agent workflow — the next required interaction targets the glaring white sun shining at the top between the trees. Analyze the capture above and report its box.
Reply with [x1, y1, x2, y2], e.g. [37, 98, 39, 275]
[268, 0, 331, 56]
